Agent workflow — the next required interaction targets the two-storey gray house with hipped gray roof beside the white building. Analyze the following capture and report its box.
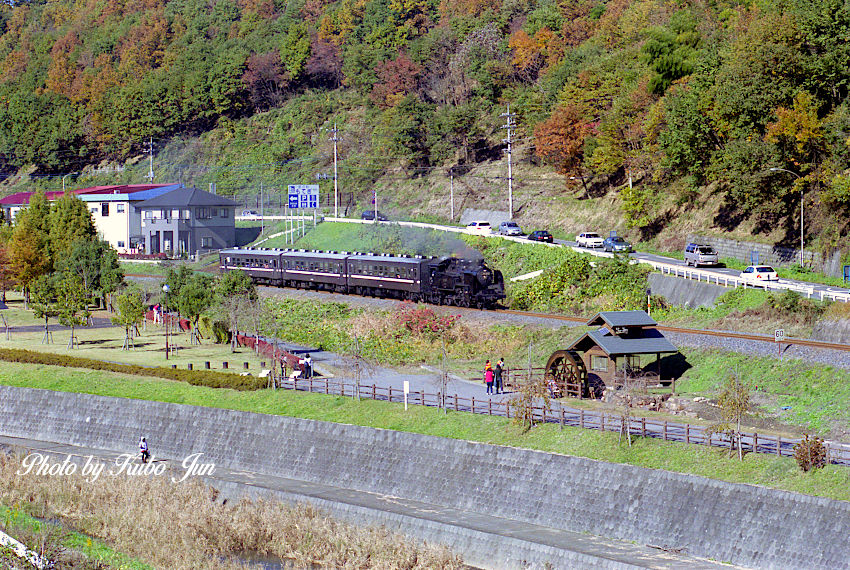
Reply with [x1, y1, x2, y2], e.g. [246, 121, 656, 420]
[136, 188, 238, 255]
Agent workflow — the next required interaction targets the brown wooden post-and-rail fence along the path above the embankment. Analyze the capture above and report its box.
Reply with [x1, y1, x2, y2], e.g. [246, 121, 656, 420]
[277, 378, 850, 465]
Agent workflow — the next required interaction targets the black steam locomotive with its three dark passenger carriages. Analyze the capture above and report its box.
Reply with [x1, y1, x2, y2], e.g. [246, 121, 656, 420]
[219, 248, 505, 308]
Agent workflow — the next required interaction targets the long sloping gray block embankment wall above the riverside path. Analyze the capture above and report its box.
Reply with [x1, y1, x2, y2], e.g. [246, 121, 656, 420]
[0, 386, 850, 568]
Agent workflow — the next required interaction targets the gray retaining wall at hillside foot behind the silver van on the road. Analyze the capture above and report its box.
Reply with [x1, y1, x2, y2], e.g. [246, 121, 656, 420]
[688, 234, 842, 277]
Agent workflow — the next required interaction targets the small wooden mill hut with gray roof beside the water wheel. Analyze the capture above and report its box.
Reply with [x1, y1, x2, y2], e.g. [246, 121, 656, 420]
[567, 311, 679, 386]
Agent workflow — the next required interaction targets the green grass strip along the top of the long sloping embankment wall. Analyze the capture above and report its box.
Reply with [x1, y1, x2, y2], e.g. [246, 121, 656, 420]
[0, 363, 850, 501]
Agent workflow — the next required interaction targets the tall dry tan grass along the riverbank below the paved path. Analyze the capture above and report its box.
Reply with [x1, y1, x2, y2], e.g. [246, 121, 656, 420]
[0, 454, 463, 570]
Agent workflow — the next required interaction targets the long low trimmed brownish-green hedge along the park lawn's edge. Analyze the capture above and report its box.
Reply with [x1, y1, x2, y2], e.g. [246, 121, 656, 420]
[0, 348, 266, 390]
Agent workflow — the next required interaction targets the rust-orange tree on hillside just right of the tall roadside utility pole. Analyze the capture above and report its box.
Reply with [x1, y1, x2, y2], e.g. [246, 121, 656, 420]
[534, 105, 594, 174]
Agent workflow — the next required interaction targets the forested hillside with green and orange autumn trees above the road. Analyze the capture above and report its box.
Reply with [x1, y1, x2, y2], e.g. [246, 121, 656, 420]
[0, 0, 850, 248]
